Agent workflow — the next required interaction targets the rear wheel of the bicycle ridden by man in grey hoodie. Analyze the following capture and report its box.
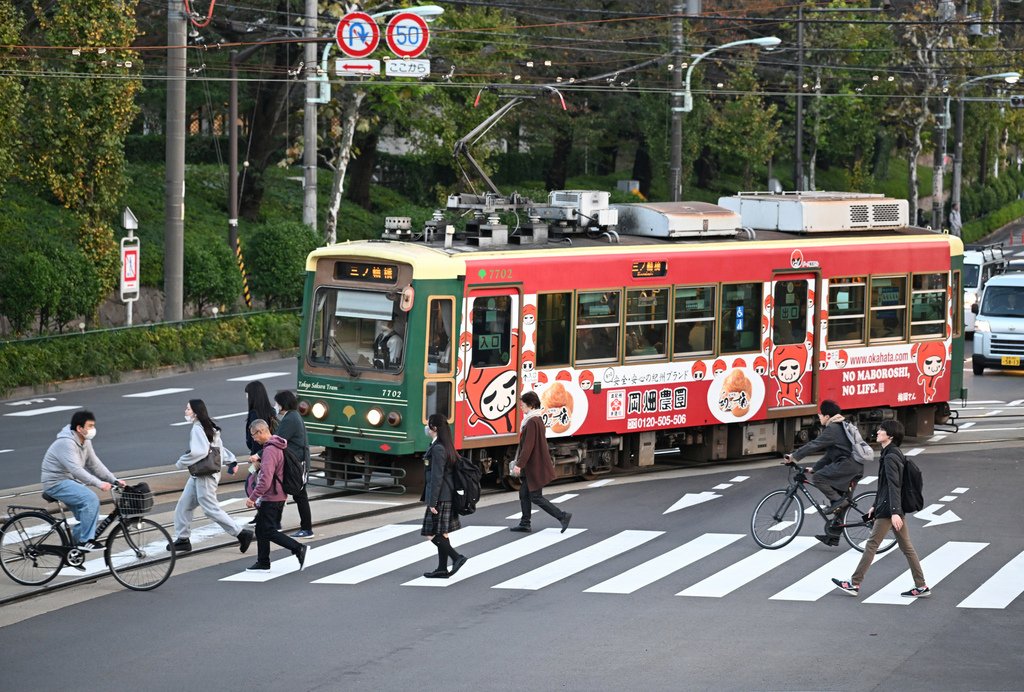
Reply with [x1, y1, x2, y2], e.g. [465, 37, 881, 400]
[0, 512, 71, 587]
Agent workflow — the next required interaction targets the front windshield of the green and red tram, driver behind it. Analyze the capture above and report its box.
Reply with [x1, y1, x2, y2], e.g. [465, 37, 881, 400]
[306, 287, 407, 377]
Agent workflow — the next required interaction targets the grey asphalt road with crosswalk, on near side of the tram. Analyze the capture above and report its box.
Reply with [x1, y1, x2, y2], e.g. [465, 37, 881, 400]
[0, 431, 1024, 691]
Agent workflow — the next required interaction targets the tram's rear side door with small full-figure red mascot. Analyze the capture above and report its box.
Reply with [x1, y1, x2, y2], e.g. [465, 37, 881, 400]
[765, 272, 818, 416]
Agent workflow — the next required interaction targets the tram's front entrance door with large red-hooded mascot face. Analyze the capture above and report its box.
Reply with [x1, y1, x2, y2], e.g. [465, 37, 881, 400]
[458, 287, 522, 442]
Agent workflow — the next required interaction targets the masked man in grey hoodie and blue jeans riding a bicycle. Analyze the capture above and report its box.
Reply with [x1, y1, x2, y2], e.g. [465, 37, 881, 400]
[40, 410, 124, 551]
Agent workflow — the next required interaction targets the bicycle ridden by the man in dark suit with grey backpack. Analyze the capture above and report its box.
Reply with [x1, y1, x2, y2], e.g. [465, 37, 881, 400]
[751, 462, 896, 553]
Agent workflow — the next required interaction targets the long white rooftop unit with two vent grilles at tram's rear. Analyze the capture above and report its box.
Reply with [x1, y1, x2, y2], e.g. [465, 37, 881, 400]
[718, 191, 910, 233]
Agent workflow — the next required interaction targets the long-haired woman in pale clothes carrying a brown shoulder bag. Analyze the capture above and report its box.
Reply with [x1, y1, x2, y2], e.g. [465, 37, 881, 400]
[167, 399, 254, 553]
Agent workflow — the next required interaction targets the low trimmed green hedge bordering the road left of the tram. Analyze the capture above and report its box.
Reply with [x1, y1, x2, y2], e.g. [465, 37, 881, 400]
[0, 310, 300, 395]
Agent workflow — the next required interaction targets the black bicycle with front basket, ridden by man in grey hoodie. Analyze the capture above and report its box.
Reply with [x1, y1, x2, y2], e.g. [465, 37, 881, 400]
[0, 485, 175, 591]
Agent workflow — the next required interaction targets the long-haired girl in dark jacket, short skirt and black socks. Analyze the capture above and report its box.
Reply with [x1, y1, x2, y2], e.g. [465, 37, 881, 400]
[420, 414, 469, 579]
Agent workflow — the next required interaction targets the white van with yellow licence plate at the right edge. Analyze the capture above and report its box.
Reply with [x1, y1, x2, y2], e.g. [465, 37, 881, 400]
[971, 273, 1024, 375]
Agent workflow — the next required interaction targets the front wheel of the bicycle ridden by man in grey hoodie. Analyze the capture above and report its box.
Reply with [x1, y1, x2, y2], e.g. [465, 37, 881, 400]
[104, 517, 174, 591]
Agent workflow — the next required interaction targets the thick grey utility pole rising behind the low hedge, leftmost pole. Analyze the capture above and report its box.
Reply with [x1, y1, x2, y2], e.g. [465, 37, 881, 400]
[164, 0, 187, 321]
